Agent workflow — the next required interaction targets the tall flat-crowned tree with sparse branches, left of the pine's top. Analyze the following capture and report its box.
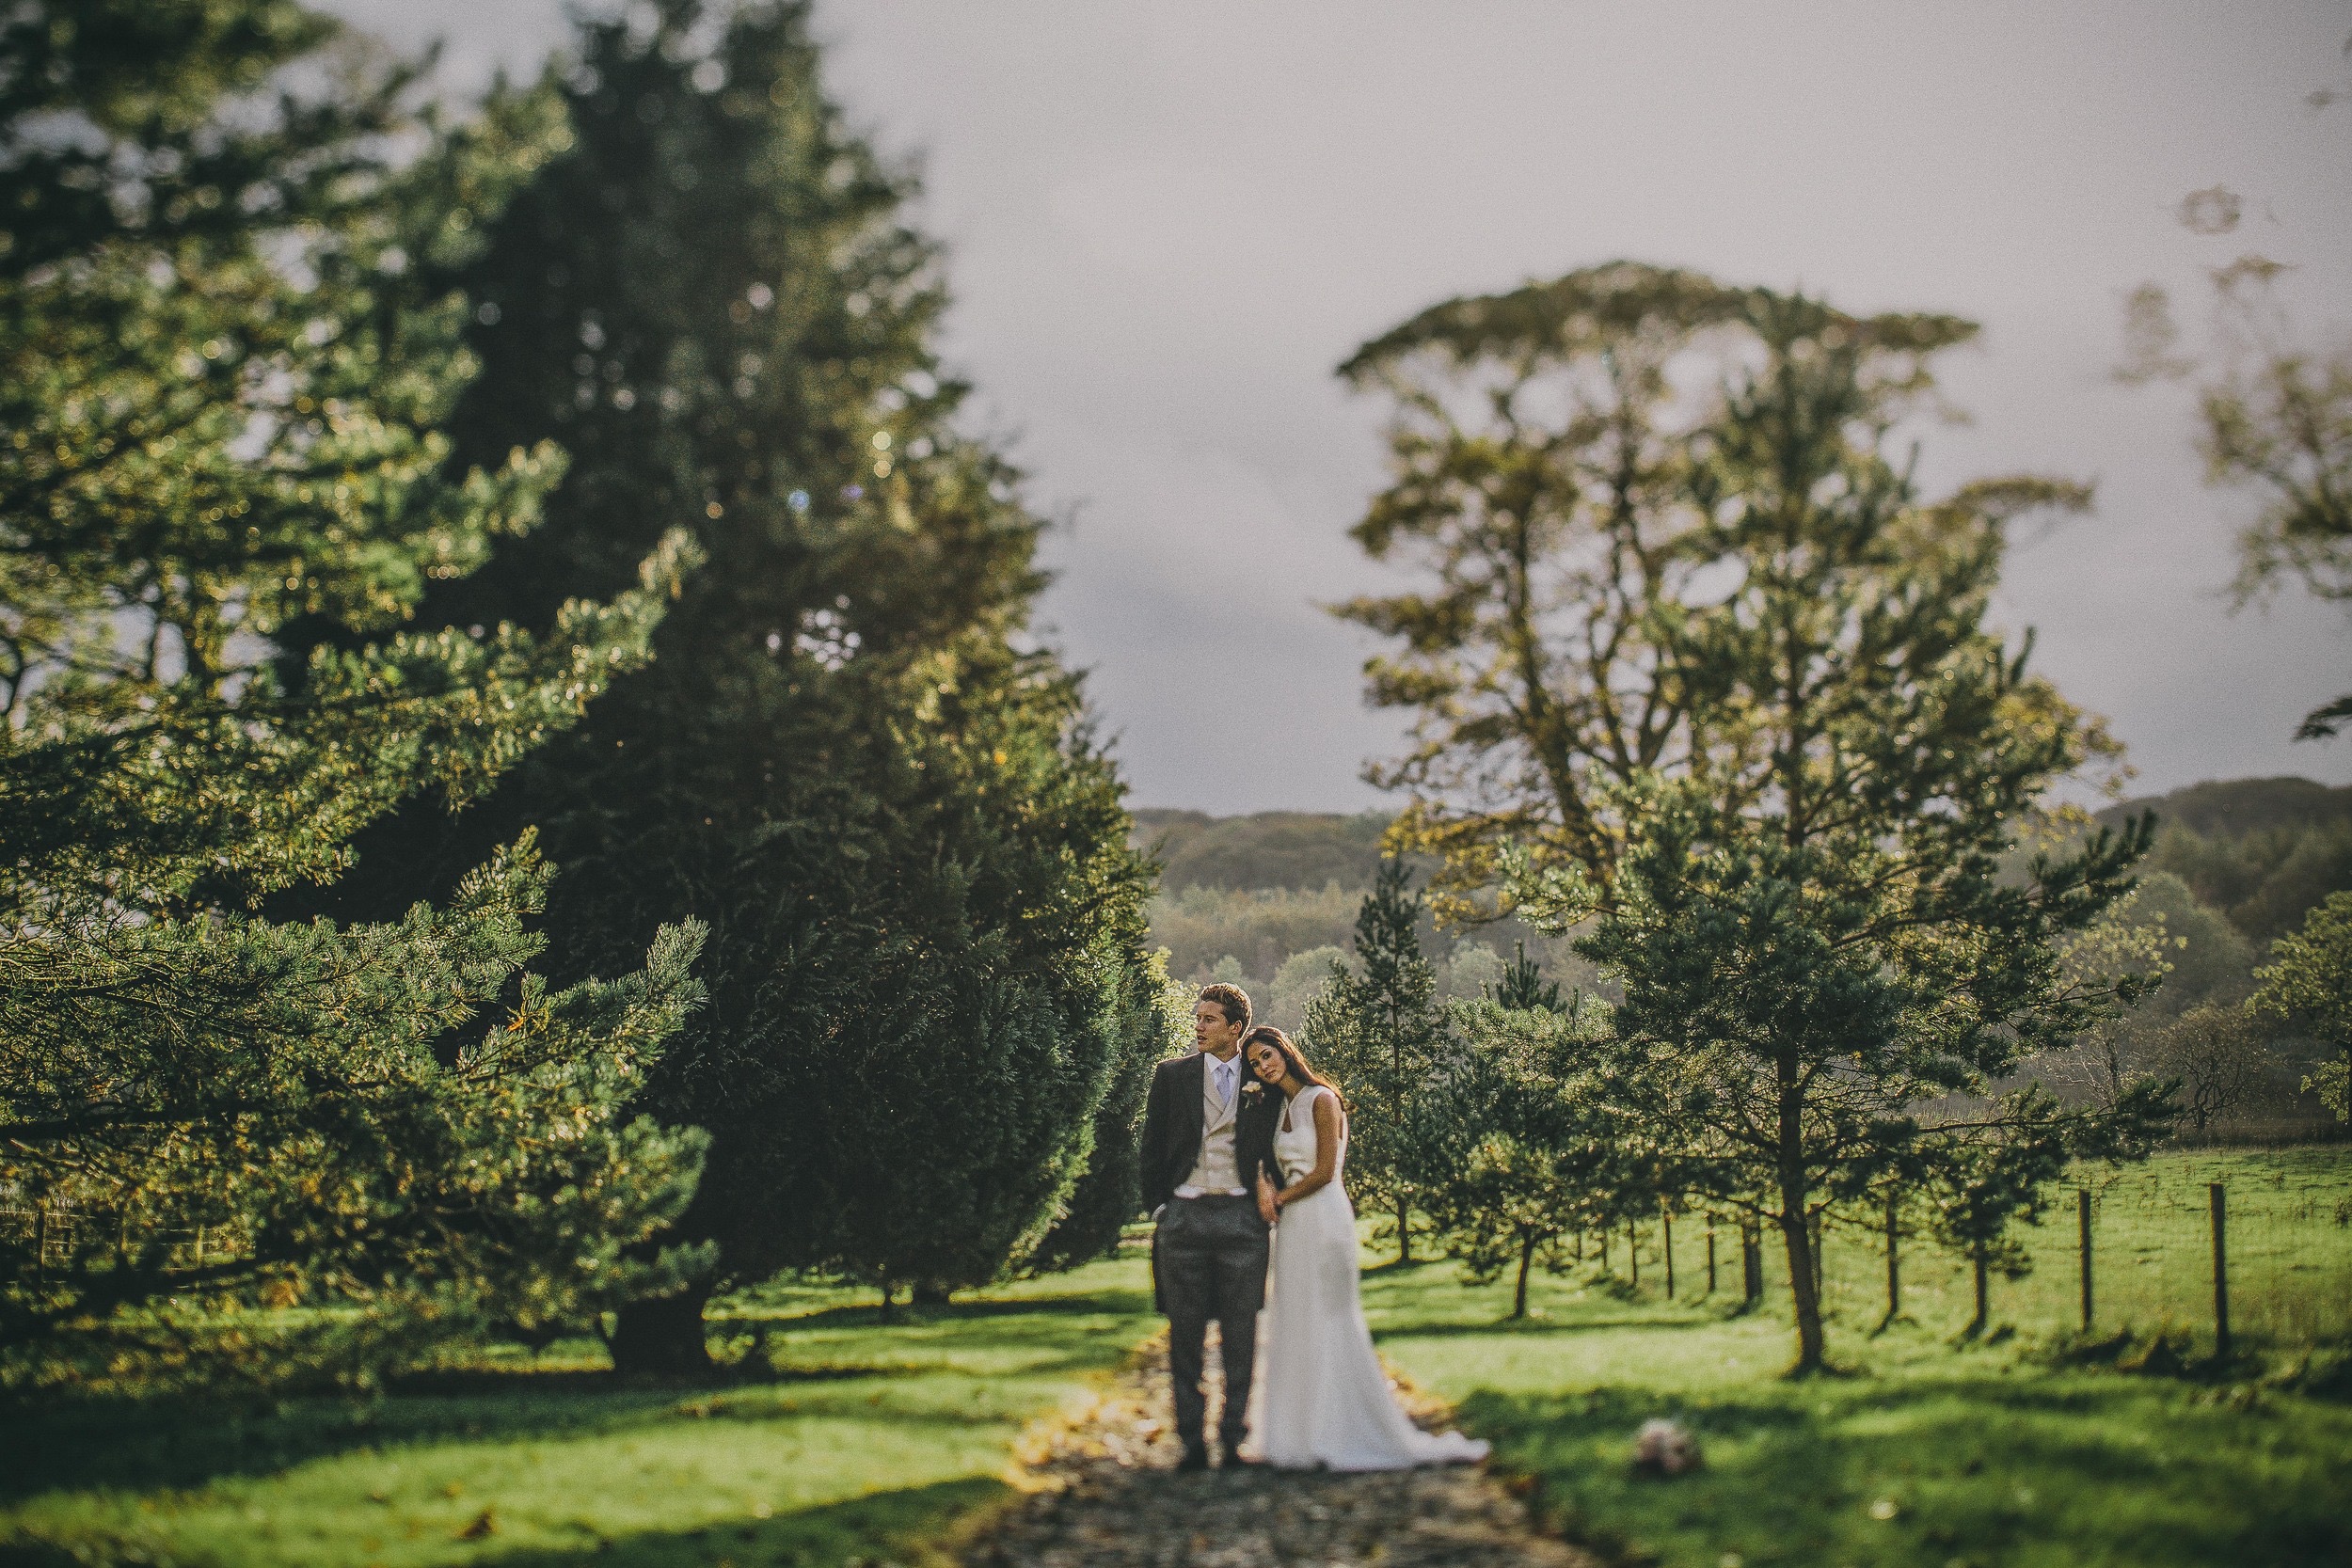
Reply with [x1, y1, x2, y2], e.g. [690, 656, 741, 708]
[1336, 261, 1740, 917]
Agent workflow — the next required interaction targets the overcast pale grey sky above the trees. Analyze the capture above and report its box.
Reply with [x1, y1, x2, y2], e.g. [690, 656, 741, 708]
[329, 0, 2352, 811]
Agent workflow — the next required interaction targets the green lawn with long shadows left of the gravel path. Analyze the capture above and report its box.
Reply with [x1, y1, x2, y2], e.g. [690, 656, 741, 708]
[0, 1260, 1151, 1568]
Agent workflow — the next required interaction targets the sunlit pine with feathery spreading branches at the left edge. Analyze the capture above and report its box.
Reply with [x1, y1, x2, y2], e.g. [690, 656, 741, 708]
[0, 0, 701, 1380]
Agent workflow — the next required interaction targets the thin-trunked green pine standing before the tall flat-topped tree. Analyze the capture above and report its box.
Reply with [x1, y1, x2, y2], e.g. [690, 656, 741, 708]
[1524, 292, 2162, 1369]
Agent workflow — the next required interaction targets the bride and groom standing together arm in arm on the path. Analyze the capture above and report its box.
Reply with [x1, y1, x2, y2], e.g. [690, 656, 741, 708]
[1143, 985, 1486, 1469]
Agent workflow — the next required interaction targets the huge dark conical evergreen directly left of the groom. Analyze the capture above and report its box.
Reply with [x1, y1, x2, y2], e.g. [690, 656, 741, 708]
[289, 0, 1162, 1364]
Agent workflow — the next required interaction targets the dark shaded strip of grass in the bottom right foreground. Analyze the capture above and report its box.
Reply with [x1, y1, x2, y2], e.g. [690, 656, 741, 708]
[1461, 1373, 2352, 1568]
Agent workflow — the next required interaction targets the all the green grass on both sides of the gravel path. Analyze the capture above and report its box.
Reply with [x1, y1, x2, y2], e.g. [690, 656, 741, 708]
[0, 1149, 2352, 1568]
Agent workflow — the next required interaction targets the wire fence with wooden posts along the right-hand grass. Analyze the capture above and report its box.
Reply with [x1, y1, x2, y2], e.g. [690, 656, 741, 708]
[1588, 1145, 2352, 1352]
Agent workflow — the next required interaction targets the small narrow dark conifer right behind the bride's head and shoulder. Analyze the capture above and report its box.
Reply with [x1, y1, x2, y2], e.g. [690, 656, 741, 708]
[1303, 858, 1461, 1262]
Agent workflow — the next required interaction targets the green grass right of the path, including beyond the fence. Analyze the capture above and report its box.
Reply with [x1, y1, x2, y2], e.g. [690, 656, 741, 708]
[1367, 1149, 2352, 1568]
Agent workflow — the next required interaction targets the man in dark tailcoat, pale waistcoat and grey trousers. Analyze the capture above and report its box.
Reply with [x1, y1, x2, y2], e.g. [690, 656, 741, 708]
[1143, 985, 1282, 1469]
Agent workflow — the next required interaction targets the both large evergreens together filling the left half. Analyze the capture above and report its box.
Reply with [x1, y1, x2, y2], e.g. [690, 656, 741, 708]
[0, 0, 1181, 1383]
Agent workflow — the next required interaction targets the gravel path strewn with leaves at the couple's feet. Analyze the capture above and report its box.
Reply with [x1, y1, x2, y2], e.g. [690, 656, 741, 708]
[962, 1338, 1593, 1568]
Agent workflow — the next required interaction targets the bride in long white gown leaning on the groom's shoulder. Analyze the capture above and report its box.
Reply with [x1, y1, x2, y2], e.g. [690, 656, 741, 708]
[1242, 1027, 1486, 1469]
